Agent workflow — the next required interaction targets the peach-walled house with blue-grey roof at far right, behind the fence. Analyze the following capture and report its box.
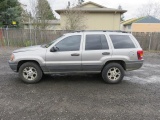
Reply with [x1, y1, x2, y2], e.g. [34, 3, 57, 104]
[121, 16, 160, 32]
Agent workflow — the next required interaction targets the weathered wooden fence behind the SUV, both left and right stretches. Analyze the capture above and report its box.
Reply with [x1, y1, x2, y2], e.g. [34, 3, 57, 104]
[0, 29, 160, 51]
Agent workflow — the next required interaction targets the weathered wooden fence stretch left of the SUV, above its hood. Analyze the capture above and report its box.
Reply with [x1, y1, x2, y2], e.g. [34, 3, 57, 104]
[0, 29, 69, 47]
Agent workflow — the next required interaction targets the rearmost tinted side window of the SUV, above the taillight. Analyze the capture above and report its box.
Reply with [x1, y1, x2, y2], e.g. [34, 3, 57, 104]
[110, 35, 135, 49]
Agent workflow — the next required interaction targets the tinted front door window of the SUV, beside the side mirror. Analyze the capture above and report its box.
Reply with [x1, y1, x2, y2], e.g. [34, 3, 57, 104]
[55, 35, 81, 51]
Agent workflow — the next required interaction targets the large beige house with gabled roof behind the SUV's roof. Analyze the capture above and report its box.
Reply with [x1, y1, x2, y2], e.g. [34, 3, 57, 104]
[56, 2, 126, 30]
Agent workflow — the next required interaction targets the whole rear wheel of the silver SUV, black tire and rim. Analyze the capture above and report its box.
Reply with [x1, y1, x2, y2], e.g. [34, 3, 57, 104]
[102, 63, 124, 84]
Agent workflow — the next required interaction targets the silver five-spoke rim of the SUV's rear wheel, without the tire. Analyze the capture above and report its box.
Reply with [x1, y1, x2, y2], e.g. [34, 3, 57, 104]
[107, 67, 121, 81]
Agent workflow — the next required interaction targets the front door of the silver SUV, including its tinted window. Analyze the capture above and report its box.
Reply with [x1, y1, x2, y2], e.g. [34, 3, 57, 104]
[46, 34, 82, 72]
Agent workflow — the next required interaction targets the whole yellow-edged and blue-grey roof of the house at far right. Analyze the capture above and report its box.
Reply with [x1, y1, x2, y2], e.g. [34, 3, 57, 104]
[121, 16, 160, 25]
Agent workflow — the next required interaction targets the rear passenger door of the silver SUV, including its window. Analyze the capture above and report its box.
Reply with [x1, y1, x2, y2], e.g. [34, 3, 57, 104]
[82, 33, 112, 72]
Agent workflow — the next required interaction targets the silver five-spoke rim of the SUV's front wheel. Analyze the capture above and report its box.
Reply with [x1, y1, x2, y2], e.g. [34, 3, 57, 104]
[23, 67, 37, 81]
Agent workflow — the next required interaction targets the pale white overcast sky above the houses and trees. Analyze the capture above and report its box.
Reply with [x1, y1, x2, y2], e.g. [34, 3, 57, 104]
[20, 0, 160, 19]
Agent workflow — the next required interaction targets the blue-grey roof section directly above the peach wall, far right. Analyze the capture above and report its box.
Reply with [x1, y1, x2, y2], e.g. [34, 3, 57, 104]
[135, 16, 160, 23]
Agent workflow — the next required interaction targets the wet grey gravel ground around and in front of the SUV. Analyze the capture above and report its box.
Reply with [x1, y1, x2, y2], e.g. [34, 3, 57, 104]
[0, 48, 160, 120]
